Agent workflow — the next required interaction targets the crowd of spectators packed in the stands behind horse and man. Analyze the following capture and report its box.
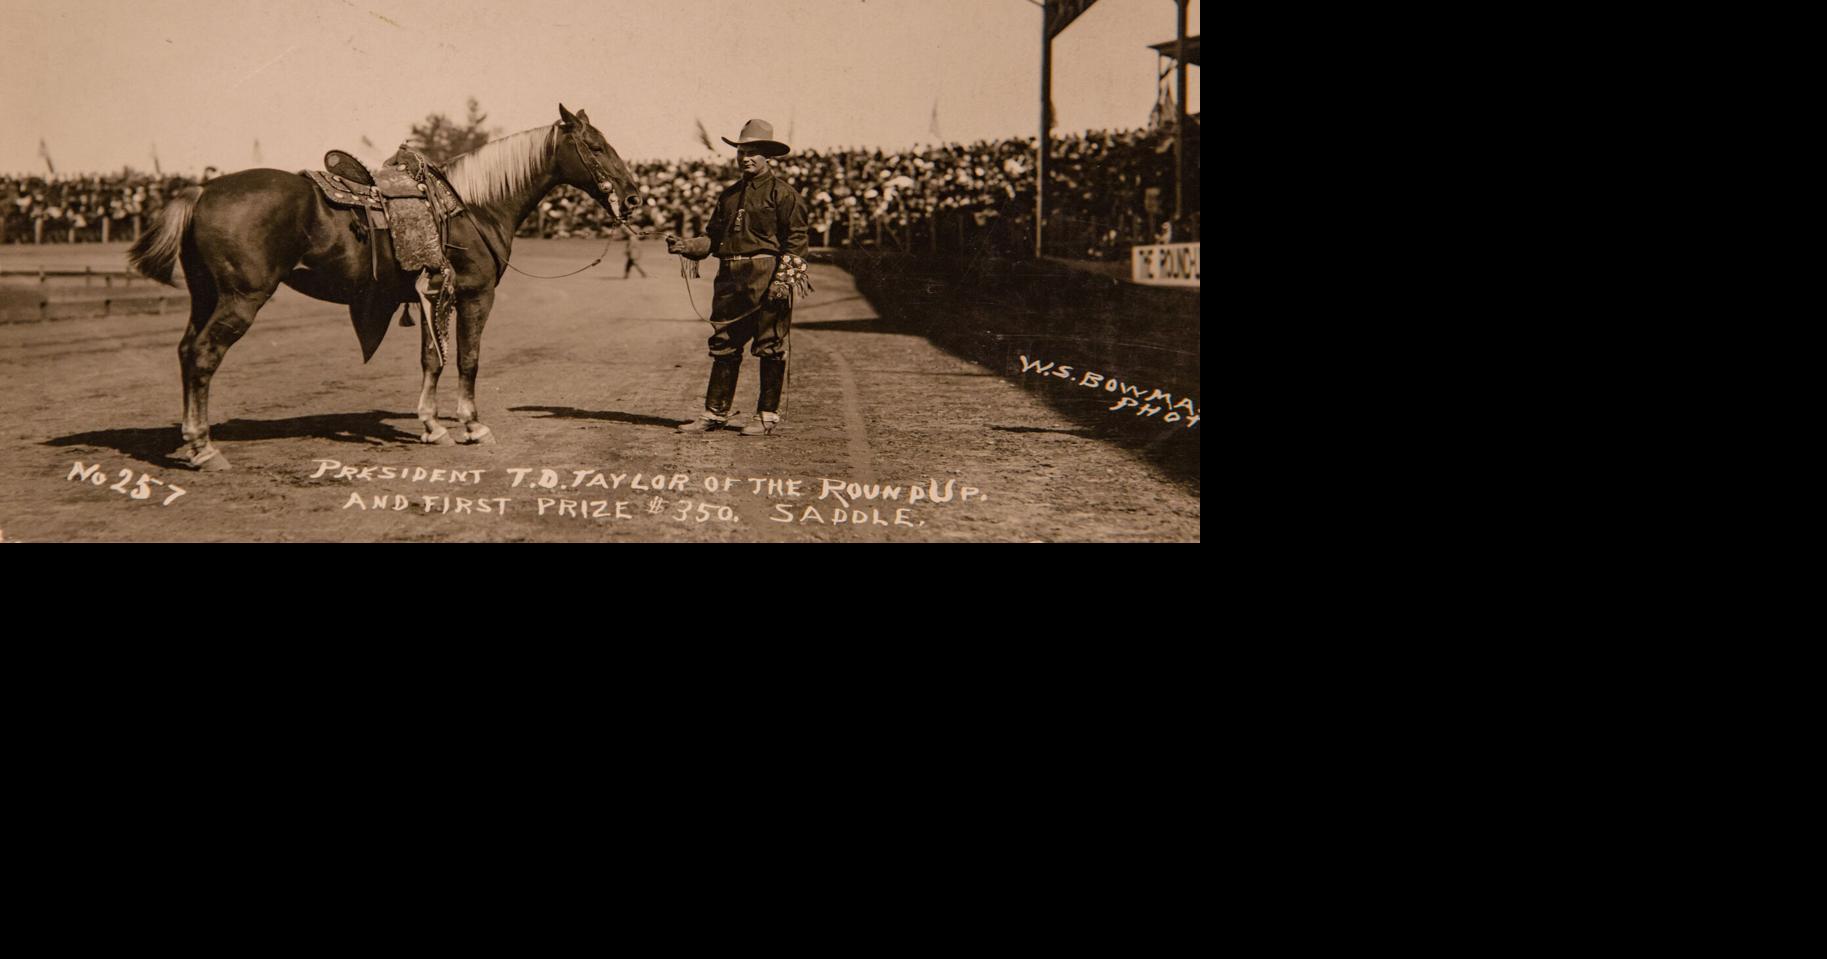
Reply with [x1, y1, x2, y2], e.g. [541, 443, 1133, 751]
[0, 130, 1199, 259]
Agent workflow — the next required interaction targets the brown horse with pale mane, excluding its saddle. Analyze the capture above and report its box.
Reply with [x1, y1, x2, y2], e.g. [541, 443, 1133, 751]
[128, 104, 639, 469]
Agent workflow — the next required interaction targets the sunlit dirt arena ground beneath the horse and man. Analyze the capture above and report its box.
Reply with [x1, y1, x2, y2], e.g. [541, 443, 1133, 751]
[0, 239, 1202, 544]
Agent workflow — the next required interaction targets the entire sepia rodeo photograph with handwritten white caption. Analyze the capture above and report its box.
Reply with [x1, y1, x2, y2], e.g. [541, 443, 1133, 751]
[0, 0, 1208, 546]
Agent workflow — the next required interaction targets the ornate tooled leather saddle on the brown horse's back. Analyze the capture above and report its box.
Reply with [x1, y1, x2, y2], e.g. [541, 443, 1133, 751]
[305, 146, 462, 362]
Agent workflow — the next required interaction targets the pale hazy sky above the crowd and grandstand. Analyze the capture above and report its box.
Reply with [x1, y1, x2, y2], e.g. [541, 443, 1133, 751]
[0, 0, 1200, 174]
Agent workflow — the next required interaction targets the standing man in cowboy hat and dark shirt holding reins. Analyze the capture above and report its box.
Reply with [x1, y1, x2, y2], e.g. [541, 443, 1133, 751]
[667, 121, 806, 437]
